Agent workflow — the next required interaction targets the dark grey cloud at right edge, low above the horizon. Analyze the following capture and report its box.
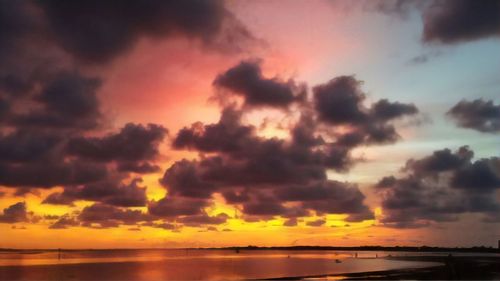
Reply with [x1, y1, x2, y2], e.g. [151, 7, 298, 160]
[375, 146, 500, 228]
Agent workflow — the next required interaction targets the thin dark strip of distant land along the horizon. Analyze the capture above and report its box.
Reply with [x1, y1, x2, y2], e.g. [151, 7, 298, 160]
[0, 245, 500, 253]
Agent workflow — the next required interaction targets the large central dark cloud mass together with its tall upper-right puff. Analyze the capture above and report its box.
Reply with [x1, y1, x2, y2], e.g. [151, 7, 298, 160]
[168, 73, 418, 221]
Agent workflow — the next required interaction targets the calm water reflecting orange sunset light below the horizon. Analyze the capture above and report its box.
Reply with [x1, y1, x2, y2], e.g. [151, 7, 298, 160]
[0, 250, 446, 280]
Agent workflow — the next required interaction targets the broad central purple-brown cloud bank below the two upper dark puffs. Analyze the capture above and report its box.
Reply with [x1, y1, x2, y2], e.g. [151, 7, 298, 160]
[167, 108, 373, 221]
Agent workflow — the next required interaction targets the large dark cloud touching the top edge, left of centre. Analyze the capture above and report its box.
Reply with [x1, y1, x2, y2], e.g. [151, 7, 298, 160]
[37, 0, 253, 63]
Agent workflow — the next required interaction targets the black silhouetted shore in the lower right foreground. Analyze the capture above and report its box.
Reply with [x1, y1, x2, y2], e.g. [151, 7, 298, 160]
[270, 256, 500, 280]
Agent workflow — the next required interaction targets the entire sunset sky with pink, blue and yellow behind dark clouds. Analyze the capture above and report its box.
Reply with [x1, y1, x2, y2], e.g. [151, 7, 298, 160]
[0, 0, 500, 248]
